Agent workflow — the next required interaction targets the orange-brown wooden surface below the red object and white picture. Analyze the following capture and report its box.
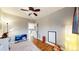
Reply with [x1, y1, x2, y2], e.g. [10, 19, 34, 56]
[33, 39, 61, 51]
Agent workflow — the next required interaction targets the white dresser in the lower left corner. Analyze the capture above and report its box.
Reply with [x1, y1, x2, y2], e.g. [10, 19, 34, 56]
[0, 38, 10, 51]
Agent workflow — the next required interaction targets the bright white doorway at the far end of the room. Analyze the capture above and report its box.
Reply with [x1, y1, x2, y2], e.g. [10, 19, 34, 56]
[28, 23, 37, 41]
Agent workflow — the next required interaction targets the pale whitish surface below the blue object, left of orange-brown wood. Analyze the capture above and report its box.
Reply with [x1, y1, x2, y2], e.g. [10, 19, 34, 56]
[10, 41, 40, 51]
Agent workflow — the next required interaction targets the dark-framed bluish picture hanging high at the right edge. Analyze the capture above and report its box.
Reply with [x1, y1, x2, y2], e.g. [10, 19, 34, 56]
[72, 7, 79, 34]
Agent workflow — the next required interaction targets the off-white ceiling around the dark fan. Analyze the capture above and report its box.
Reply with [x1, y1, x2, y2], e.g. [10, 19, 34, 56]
[1, 7, 63, 19]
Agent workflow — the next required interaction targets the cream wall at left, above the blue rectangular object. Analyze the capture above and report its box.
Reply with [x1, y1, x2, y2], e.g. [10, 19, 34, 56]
[1, 12, 34, 41]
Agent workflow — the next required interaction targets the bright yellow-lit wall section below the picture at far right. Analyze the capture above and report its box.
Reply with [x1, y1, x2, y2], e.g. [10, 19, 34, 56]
[65, 18, 79, 51]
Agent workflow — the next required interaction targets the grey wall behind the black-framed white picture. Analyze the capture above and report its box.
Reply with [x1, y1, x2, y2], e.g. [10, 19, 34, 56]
[37, 8, 73, 47]
